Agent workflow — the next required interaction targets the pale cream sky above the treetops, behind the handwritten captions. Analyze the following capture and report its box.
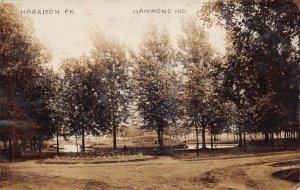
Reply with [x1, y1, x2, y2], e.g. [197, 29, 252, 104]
[13, 0, 225, 69]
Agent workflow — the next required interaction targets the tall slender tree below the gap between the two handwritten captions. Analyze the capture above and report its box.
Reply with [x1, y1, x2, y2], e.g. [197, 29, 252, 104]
[91, 31, 130, 149]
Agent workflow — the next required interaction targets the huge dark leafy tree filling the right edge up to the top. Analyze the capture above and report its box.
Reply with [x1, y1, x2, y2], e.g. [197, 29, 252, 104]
[201, 1, 300, 145]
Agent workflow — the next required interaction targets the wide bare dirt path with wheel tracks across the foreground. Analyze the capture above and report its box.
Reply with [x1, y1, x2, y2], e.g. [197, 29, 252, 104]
[0, 152, 300, 190]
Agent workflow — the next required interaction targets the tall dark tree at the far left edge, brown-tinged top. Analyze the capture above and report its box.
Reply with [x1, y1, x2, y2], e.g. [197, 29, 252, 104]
[0, 3, 51, 155]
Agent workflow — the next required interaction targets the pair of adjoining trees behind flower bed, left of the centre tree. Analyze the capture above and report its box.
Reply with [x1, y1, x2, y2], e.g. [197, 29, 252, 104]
[54, 32, 130, 151]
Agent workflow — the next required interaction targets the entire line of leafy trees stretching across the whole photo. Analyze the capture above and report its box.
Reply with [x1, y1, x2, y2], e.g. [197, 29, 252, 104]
[0, 1, 300, 154]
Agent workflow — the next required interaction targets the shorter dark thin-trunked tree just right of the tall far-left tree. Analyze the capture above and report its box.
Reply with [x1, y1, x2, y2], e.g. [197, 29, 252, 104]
[19, 67, 57, 152]
